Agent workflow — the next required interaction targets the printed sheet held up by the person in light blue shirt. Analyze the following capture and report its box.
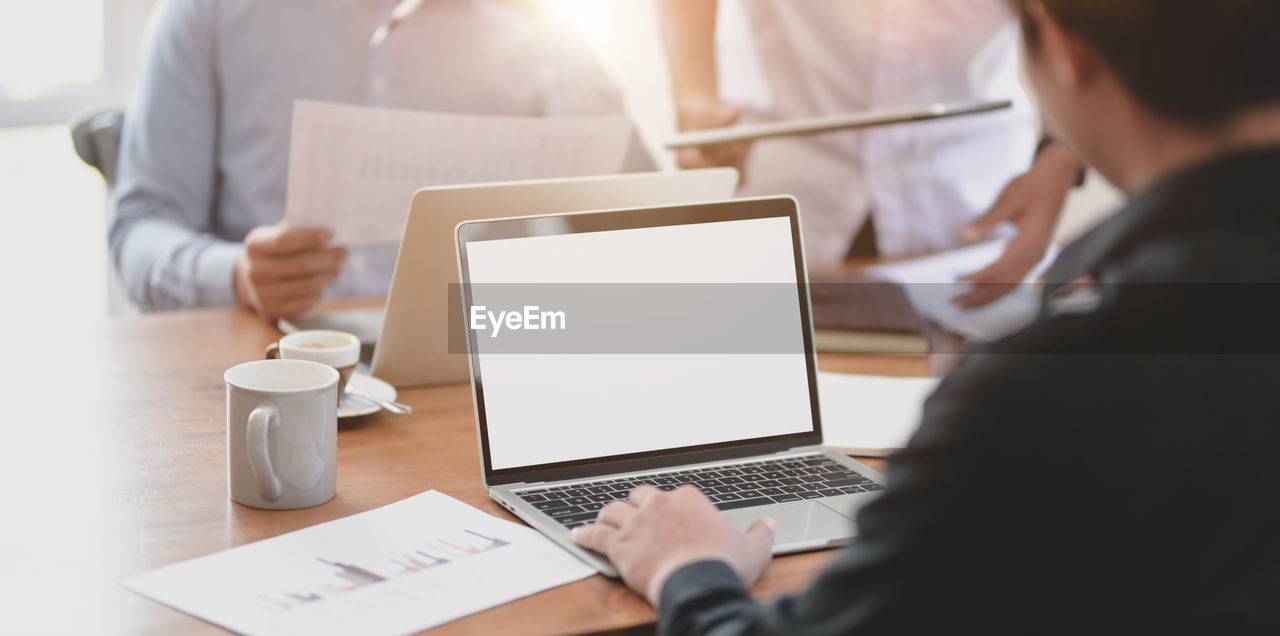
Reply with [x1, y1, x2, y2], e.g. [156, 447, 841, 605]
[284, 100, 631, 244]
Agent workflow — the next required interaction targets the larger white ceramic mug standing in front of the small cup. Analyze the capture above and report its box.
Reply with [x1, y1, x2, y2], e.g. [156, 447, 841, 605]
[223, 360, 338, 511]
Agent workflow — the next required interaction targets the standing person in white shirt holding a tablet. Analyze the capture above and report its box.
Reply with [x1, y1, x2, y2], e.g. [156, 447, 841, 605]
[659, 0, 1080, 306]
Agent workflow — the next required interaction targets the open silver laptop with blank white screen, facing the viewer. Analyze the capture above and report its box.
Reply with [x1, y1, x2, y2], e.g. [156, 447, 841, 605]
[456, 197, 884, 576]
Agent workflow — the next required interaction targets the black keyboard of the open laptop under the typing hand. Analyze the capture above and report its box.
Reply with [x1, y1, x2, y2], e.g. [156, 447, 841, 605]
[516, 454, 884, 529]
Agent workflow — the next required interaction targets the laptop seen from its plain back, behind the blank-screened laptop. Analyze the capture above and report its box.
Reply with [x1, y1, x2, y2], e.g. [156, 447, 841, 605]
[353, 168, 737, 386]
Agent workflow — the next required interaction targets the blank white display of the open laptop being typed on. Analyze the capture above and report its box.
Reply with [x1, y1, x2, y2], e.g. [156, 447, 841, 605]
[462, 200, 818, 481]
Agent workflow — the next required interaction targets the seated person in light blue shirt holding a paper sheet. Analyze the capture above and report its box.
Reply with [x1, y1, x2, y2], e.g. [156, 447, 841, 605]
[109, 0, 622, 319]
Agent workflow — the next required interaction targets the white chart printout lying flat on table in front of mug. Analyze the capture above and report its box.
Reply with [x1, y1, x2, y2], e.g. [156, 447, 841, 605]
[123, 490, 595, 636]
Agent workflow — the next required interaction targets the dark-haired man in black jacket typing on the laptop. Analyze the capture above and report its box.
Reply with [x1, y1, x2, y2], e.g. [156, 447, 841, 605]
[575, 0, 1280, 635]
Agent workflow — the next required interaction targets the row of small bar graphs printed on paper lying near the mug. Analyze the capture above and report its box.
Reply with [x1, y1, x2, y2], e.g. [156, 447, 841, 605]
[250, 530, 511, 612]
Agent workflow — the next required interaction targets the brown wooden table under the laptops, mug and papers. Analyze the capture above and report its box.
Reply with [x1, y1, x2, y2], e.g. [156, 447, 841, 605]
[0, 304, 947, 633]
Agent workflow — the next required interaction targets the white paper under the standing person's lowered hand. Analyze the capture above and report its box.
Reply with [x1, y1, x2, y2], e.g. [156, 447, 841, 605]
[867, 241, 1059, 342]
